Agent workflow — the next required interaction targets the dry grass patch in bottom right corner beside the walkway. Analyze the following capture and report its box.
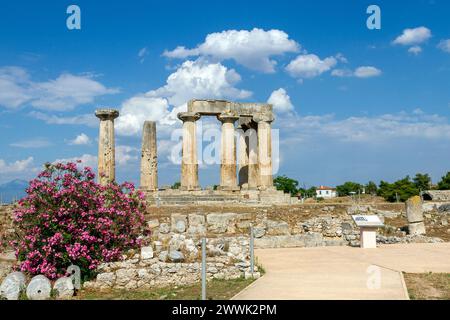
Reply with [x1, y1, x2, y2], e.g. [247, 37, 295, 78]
[403, 272, 450, 300]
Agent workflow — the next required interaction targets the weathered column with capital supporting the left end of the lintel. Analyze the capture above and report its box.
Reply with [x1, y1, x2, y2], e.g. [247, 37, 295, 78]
[178, 112, 200, 190]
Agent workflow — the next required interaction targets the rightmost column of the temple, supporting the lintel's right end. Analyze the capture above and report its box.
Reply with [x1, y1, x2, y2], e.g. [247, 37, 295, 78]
[254, 115, 274, 190]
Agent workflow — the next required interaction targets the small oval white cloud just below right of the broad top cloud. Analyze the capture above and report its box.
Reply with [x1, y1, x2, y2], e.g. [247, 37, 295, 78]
[286, 54, 337, 78]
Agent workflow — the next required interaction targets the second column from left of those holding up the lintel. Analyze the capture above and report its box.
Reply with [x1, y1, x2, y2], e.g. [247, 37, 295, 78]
[217, 113, 239, 190]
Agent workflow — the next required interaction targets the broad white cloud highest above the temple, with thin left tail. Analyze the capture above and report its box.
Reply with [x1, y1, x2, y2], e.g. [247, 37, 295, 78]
[163, 28, 300, 73]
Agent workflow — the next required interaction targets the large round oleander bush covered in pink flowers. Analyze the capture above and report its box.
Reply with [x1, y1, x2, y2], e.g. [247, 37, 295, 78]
[13, 163, 147, 279]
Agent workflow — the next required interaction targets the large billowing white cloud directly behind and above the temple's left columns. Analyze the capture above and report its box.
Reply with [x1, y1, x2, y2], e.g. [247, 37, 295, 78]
[116, 59, 252, 135]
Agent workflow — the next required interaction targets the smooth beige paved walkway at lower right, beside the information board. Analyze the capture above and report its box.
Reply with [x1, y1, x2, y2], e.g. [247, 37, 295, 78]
[233, 243, 450, 300]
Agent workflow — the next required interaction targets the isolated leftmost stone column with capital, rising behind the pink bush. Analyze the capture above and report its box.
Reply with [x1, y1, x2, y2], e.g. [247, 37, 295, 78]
[95, 109, 119, 185]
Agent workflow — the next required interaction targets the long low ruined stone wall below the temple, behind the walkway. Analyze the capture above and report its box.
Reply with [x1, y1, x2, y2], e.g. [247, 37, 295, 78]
[147, 204, 403, 248]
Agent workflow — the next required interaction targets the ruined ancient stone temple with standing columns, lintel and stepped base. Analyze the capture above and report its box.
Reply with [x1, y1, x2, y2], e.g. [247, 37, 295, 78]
[96, 100, 297, 205]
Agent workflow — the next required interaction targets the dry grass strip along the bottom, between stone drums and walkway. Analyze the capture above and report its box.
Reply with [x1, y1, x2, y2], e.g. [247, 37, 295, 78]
[75, 278, 254, 300]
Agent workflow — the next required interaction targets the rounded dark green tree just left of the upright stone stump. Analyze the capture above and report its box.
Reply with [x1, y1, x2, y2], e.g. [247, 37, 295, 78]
[378, 176, 419, 202]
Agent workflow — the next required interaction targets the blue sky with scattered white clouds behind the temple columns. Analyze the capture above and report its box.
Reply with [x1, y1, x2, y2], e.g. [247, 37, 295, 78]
[0, 0, 450, 186]
